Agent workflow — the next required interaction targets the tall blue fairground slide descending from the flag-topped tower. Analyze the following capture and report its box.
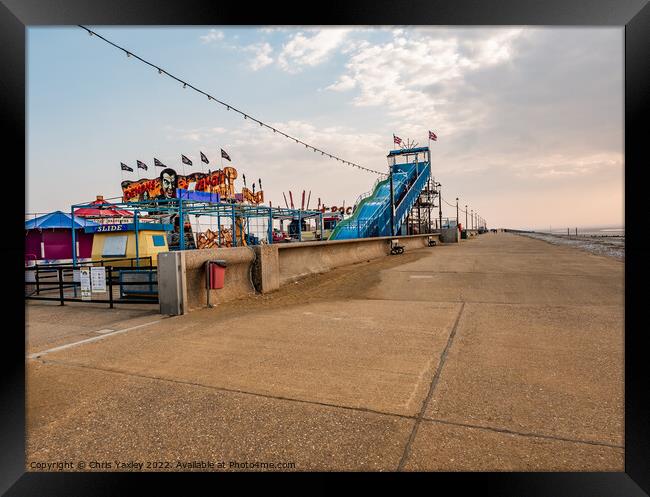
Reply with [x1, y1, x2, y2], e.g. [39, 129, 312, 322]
[329, 155, 431, 240]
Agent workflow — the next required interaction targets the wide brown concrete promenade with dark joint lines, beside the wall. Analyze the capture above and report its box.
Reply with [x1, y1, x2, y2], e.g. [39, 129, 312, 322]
[27, 233, 624, 471]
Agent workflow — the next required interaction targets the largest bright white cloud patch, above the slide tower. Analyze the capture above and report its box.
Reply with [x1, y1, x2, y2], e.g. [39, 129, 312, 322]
[327, 28, 523, 134]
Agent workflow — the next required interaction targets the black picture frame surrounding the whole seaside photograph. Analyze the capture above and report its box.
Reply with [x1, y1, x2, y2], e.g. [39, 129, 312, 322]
[0, 0, 650, 497]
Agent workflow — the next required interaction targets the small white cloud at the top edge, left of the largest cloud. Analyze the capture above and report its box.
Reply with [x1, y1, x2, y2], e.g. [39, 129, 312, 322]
[278, 28, 351, 73]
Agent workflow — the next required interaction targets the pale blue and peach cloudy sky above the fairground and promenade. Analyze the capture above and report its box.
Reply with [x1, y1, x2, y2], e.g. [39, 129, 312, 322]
[25, 26, 624, 229]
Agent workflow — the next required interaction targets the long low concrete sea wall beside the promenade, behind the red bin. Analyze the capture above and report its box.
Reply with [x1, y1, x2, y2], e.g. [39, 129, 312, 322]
[158, 235, 440, 314]
